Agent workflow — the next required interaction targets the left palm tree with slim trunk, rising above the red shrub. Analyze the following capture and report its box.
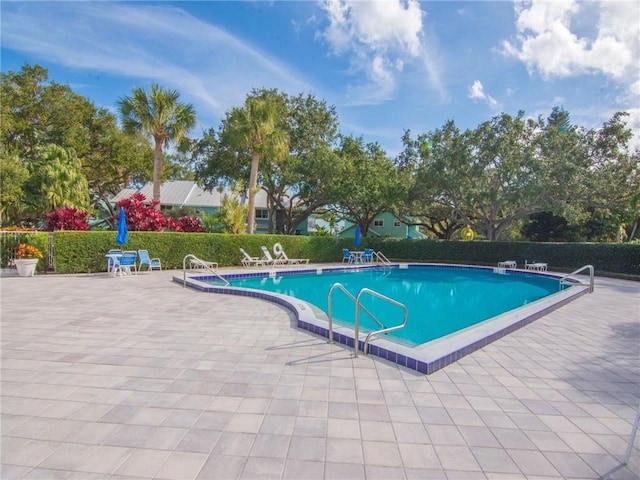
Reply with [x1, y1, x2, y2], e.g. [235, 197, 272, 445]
[118, 84, 196, 209]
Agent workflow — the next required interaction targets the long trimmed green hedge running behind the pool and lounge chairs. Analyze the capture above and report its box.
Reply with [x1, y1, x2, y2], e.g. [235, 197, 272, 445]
[2, 231, 640, 276]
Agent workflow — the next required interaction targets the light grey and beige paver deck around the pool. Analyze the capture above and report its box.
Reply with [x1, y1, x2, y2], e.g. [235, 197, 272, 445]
[0, 270, 640, 480]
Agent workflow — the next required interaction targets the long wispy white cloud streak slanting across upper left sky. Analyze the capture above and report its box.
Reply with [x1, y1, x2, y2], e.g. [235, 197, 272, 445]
[2, 2, 310, 122]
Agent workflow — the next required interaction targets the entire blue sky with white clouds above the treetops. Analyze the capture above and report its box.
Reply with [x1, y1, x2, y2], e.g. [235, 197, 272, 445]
[0, 0, 640, 156]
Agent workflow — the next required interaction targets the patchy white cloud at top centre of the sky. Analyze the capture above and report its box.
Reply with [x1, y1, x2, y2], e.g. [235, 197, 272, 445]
[318, 0, 442, 103]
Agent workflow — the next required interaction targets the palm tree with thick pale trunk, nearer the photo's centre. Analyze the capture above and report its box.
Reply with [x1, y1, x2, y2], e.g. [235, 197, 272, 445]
[222, 91, 289, 234]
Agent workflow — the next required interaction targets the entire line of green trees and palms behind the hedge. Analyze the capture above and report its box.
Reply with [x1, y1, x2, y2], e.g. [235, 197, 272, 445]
[0, 65, 640, 241]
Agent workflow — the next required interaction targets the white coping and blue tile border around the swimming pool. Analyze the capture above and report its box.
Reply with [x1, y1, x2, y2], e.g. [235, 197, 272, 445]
[173, 263, 589, 375]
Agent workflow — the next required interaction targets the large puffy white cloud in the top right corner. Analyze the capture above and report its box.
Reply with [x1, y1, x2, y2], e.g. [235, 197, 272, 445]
[503, 0, 640, 82]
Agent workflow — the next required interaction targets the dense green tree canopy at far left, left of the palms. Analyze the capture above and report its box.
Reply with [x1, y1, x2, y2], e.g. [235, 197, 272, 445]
[0, 65, 152, 224]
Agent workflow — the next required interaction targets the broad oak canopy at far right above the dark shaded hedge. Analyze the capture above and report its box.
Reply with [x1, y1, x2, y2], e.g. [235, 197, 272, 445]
[399, 109, 639, 240]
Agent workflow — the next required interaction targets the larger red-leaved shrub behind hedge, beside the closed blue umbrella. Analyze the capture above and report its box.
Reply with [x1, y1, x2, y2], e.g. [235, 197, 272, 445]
[115, 192, 204, 232]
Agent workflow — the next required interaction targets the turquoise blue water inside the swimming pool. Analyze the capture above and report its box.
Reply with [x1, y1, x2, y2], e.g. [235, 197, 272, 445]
[225, 266, 559, 345]
